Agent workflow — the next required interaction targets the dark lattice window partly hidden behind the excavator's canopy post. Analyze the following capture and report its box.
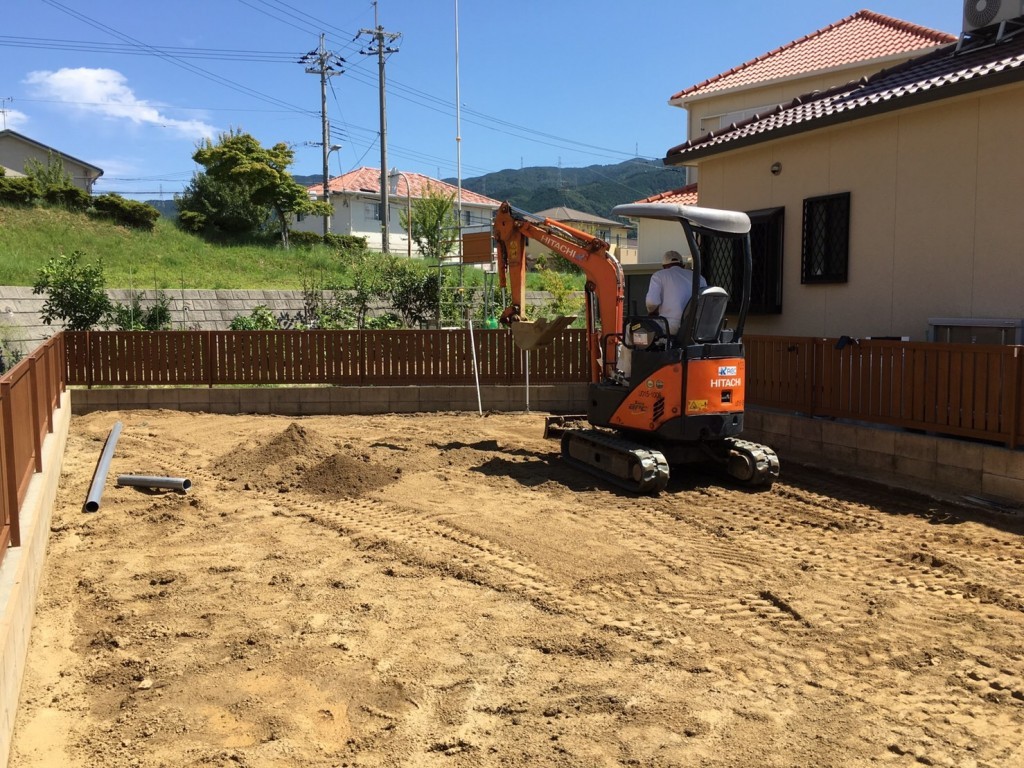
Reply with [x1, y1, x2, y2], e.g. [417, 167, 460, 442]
[697, 208, 785, 314]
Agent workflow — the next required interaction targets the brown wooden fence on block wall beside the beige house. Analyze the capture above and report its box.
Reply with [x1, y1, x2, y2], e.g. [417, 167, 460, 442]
[744, 336, 1024, 449]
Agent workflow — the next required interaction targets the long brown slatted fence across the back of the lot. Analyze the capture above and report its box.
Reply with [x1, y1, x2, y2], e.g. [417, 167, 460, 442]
[63, 330, 590, 387]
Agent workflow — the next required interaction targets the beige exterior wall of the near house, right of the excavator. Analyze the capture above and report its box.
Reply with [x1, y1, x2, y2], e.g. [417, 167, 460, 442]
[688, 85, 1024, 340]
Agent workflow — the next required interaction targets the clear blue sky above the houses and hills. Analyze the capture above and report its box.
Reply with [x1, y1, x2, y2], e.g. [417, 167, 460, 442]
[0, 0, 963, 199]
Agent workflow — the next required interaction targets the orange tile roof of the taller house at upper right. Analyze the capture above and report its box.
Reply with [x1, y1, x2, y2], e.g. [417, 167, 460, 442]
[669, 10, 956, 105]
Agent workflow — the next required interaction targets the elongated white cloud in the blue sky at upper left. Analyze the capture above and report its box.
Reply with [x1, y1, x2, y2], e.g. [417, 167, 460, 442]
[25, 67, 217, 138]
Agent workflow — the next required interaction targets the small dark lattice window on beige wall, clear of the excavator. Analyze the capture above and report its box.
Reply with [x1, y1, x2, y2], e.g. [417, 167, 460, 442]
[800, 193, 850, 284]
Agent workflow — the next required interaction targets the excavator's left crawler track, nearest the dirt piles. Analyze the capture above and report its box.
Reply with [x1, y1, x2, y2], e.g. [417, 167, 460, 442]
[561, 429, 669, 494]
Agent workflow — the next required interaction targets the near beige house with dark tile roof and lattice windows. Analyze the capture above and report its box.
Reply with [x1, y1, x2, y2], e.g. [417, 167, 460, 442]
[659, 9, 1024, 344]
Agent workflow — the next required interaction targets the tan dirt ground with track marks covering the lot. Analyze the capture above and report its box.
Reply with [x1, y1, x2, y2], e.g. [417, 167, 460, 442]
[10, 411, 1024, 768]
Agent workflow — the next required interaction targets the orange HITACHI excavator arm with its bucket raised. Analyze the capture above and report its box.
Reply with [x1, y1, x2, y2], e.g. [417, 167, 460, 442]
[493, 203, 626, 382]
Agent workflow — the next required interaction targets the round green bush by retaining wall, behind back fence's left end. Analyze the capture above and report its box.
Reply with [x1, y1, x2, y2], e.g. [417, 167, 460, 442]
[32, 251, 114, 331]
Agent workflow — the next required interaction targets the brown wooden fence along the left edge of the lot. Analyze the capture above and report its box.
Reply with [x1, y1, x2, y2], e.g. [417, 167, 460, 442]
[0, 334, 65, 562]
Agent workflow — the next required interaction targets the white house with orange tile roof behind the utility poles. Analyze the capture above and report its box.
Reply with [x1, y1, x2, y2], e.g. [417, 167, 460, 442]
[293, 167, 501, 255]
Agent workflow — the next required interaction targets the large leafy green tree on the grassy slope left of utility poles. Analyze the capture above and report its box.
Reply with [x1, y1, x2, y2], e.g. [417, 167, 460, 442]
[193, 131, 330, 248]
